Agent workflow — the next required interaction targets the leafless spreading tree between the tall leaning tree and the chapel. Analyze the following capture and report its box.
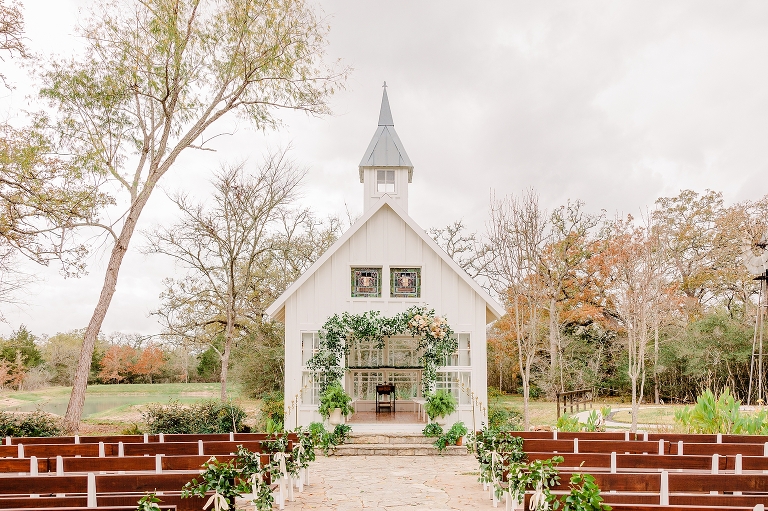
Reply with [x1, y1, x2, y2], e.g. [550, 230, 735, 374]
[148, 152, 304, 400]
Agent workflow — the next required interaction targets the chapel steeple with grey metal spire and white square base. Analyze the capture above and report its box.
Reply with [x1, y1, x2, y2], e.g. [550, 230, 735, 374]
[359, 82, 413, 212]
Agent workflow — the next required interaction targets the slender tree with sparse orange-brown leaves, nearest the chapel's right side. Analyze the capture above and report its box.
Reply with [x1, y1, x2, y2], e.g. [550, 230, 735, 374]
[488, 191, 547, 430]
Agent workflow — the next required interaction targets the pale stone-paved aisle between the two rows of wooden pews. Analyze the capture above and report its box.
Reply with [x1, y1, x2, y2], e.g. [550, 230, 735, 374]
[292, 456, 496, 511]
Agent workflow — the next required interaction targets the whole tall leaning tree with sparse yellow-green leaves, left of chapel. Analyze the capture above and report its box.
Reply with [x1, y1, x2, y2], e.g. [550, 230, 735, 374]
[39, 0, 347, 431]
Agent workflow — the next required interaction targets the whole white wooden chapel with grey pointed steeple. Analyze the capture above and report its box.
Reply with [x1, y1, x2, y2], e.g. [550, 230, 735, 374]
[267, 84, 504, 429]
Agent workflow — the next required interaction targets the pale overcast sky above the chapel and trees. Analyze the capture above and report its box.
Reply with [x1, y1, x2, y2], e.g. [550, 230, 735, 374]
[0, 0, 768, 334]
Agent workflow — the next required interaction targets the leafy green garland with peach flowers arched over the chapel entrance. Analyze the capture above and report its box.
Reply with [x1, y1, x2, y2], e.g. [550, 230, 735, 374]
[307, 305, 459, 394]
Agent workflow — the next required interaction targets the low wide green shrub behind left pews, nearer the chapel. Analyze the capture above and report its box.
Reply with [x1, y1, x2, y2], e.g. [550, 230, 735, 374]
[142, 399, 249, 434]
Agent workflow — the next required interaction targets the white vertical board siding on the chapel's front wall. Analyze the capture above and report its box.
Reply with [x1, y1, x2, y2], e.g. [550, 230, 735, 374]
[284, 206, 487, 428]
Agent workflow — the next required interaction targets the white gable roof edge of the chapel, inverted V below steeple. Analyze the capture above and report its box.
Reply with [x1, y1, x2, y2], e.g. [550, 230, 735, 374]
[266, 194, 506, 322]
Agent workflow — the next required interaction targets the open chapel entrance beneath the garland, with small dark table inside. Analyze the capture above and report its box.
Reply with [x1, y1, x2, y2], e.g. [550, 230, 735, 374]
[345, 337, 426, 423]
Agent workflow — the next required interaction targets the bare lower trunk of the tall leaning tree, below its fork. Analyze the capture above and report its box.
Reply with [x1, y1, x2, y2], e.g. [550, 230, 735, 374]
[64, 186, 154, 434]
